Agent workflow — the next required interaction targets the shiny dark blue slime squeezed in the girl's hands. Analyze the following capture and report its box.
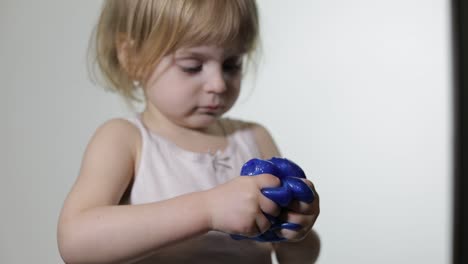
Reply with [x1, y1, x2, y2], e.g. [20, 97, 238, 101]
[231, 157, 314, 242]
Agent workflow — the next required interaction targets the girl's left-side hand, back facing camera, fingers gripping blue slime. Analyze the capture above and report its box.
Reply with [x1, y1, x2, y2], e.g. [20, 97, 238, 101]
[205, 174, 281, 237]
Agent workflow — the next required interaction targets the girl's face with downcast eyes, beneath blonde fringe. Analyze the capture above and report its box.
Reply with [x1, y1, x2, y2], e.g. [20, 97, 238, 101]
[145, 46, 243, 129]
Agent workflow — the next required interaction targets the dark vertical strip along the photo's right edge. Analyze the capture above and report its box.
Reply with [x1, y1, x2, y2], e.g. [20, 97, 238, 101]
[452, 0, 468, 264]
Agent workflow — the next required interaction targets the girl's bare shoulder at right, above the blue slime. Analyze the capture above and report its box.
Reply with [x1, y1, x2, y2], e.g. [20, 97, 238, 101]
[223, 119, 281, 159]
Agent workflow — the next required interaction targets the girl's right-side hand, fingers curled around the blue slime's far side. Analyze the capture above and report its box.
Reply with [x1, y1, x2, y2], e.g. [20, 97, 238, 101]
[276, 179, 320, 241]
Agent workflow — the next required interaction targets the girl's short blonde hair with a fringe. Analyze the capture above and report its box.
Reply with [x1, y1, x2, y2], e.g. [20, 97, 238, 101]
[89, 0, 259, 101]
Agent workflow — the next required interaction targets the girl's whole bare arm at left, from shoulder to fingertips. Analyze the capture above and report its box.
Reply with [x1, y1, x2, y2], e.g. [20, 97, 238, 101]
[57, 120, 279, 263]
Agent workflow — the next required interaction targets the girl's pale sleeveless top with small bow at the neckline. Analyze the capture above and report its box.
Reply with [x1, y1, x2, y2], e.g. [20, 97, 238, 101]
[121, 116, 272, 264]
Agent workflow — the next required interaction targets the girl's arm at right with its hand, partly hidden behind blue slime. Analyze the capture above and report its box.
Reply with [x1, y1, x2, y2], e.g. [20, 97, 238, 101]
[253, 125, 320, 264]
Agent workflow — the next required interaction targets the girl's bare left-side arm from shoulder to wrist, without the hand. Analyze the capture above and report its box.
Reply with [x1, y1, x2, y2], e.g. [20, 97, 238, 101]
[58, 120, 208, 263]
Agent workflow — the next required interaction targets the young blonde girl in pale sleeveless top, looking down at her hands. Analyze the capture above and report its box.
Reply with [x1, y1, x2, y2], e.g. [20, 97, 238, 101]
[58, 0, 319, 263]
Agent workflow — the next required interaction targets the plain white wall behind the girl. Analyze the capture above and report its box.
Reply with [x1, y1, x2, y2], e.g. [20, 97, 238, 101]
[0, 0, 451, 264]
